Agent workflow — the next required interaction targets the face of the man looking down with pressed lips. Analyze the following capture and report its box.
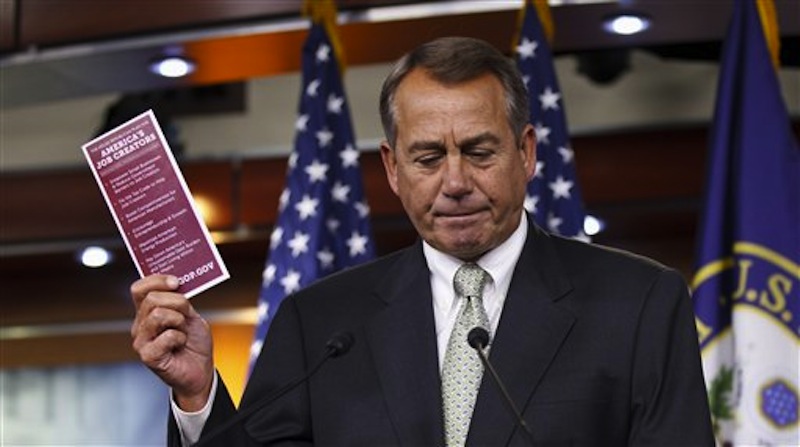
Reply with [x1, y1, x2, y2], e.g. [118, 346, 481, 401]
[381, 69, 536, 260]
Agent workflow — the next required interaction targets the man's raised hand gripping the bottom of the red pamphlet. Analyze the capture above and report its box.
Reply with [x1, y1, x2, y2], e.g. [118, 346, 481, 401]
[131, 275, 214, 412]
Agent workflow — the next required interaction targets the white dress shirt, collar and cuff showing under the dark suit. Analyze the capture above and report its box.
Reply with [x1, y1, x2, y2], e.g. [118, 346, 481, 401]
[176, 212, 528, 446]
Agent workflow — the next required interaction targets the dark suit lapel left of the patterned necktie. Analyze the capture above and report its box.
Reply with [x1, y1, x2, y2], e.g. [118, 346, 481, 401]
[366, 243, 444, 445]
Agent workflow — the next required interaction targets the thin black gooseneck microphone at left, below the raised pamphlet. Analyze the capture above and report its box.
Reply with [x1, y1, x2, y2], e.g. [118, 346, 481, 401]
[193, 332, 355, 447]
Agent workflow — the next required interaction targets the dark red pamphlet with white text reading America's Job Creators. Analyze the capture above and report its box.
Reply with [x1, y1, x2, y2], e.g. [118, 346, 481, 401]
[82, 110, 230, 298]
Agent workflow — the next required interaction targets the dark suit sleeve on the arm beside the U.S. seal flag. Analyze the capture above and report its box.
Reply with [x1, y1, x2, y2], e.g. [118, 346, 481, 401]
[628, 271, 714, 447]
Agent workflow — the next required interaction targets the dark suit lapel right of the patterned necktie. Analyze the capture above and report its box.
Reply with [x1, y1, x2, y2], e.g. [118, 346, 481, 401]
[467, 225, 575, 445]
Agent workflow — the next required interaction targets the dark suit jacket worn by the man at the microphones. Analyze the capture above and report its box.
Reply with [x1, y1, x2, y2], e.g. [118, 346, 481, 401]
[171, 225, 713, 447]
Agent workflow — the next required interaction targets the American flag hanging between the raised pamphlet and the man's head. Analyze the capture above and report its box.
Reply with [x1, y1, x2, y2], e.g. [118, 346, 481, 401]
[250, 23, 375, 365]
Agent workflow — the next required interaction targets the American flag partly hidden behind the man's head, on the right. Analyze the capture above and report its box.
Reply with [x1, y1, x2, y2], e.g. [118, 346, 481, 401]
[515, 1, 588, 240]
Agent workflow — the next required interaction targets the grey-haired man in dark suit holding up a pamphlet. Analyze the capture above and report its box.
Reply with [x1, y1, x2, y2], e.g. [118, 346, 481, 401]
[131, 38, 714, 446]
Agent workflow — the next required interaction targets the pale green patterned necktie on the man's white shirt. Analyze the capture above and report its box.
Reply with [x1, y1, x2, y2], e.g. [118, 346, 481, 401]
[442, 263, 489, 447]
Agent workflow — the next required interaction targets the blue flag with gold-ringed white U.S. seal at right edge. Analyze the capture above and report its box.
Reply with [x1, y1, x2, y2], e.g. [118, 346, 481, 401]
[693, 0, 800, 445]
